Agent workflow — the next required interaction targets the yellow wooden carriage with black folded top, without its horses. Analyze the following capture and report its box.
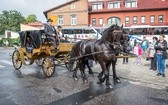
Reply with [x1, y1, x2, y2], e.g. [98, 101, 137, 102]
[12, 30, 73, 77]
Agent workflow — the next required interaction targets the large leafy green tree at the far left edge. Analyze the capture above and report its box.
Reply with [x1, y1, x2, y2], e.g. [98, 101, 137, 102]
[0, 10, 25, 35]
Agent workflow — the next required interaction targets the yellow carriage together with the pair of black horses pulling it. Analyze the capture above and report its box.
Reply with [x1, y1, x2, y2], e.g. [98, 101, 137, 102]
[12, 25, 134, 87]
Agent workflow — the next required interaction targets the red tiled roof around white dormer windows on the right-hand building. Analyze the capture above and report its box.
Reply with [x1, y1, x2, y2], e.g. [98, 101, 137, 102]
[89, 0, 168, 13]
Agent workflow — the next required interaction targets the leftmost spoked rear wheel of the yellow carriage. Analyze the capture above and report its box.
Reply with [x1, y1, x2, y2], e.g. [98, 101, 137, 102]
[12, 50, 22, 70]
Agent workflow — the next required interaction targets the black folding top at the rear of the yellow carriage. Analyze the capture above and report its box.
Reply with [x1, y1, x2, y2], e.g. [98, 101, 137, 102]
[19, 30, 44, 48]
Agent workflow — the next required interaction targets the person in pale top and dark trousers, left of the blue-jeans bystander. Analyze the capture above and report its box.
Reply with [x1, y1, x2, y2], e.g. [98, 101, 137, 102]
[148, 37, 158, 70]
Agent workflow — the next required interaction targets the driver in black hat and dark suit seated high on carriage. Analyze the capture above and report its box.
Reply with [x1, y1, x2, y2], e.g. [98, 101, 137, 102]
[44, 19, 59, 49]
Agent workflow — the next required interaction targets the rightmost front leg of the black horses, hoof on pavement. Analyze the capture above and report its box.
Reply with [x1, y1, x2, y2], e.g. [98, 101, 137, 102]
[112, 59, 121, 83]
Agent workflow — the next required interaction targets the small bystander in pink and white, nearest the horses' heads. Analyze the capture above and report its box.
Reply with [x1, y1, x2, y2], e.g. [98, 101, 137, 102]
[133, 42, 143, 65]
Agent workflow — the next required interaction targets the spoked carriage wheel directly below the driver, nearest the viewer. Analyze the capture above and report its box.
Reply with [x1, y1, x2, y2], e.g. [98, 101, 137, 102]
[42, 57, 55, 77]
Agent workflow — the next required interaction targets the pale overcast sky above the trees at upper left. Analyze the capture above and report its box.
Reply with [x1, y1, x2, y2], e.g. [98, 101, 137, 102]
[0, 0, 67, 22]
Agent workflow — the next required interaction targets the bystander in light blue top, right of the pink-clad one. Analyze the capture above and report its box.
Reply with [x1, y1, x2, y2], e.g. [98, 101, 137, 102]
[141, 36, 149, 59]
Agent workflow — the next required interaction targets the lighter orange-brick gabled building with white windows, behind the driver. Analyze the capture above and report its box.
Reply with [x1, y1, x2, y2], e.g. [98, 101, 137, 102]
[44, 0, 89, 27]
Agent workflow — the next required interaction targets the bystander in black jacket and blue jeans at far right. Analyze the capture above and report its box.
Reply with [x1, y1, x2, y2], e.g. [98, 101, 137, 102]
[155, 35, 167, 77]
